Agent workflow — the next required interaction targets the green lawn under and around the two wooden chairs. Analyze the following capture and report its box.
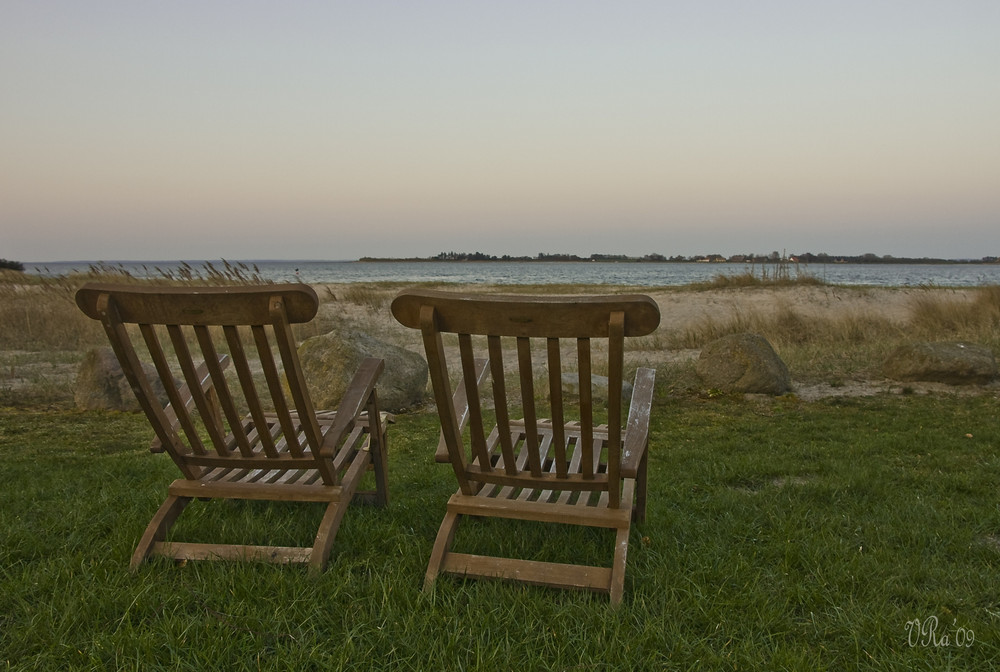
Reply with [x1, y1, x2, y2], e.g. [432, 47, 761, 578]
[0, 395, 1000, 670]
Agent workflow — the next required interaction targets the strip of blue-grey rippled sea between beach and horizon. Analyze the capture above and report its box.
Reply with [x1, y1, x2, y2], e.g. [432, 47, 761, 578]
[24, 261, 1000, 287]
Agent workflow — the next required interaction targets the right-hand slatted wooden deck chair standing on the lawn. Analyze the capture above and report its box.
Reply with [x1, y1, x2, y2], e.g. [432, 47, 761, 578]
[392, 291, 660, 604]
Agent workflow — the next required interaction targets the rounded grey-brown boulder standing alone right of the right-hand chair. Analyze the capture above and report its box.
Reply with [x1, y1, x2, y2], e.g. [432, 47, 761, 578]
[695, 334, 792, 394]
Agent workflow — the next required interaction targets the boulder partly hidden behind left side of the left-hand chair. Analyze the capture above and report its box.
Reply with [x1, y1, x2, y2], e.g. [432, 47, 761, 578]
[73, 347, 167, 411]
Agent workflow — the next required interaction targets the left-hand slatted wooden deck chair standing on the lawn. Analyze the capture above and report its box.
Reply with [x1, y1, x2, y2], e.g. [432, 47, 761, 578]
[76, 284, 389, 572]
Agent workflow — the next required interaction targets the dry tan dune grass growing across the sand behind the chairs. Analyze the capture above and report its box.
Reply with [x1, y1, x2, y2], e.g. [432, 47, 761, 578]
[0, 264, 1000, 406]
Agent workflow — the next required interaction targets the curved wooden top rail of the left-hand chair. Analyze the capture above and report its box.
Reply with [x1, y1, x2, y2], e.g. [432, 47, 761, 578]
[76, 283, 319, 325]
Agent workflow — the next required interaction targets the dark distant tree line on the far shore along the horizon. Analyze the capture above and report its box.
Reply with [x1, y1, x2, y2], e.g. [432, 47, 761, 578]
[360, 251, 1000, 264]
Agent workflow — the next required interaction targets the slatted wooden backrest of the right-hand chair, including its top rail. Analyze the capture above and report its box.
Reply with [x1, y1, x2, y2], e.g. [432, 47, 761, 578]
[392, 291, 660, 505]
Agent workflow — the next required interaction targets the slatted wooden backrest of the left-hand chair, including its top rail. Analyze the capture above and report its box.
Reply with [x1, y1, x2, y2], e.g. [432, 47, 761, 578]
[76, 283, 337, 485]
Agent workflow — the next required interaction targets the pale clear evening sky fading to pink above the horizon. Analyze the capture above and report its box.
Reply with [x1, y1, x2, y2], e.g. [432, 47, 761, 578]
[0, 0, 1000, 262]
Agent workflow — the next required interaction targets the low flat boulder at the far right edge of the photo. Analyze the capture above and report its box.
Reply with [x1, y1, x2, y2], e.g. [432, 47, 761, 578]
[883, 342, 997, 385]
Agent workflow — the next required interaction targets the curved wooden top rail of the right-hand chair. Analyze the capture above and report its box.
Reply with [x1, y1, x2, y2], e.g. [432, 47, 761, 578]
[392, 290, 660, 338]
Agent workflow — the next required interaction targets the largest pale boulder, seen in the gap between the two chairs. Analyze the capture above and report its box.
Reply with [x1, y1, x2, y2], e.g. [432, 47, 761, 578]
[299, 330, 427, 413]
